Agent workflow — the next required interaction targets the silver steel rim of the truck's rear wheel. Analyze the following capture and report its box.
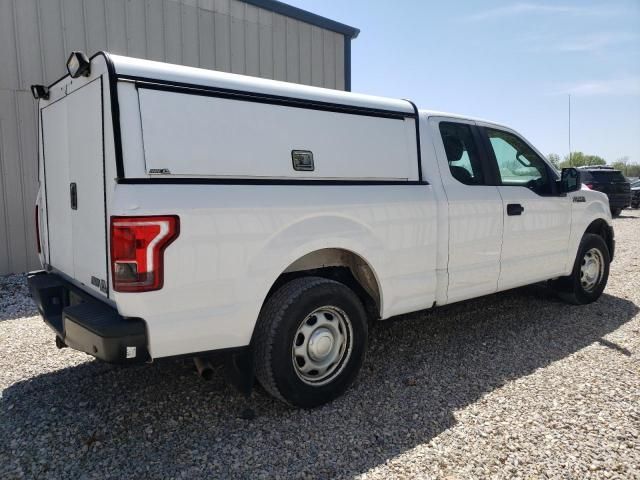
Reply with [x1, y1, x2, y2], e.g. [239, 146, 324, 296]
[291, 306, 353, 385]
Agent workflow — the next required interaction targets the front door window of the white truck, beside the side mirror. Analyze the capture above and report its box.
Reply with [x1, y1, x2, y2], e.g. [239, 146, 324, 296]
[485, 128, 553, 195]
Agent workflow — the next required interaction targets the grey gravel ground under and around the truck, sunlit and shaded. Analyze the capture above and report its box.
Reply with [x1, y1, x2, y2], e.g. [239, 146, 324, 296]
[0, 215, 640, 479]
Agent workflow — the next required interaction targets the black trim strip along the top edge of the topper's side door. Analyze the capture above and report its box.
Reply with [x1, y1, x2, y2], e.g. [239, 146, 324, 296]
[118, 75, 416, 120]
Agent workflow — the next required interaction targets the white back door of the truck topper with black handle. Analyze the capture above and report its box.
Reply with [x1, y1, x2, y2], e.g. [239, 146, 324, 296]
[40, 77, 108, 296]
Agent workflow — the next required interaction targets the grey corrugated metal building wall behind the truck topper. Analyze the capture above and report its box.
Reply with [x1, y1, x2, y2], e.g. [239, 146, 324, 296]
[0, 0, 345, 274]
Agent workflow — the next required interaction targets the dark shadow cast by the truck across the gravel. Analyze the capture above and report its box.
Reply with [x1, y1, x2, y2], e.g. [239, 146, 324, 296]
[0, 285, 639, 478]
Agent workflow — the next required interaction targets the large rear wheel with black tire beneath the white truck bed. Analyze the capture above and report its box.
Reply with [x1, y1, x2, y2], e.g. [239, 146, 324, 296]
[253, 277, 368, 408]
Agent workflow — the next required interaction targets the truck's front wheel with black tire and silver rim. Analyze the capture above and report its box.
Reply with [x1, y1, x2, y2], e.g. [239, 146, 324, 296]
[552, 233, 611, 305]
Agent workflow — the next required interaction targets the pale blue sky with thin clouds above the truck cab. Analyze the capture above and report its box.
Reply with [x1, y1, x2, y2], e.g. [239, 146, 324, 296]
[285, 0, 640, 163]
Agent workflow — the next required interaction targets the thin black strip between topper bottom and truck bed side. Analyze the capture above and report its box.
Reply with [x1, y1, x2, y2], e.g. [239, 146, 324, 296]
[116, 177, 430, 186]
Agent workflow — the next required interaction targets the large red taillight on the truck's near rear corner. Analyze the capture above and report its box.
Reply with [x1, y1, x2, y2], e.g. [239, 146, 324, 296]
[111, 215, 180, 292]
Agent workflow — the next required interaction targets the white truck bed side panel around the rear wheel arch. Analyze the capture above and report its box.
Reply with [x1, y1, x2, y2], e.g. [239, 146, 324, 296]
[112, 184, 437, 357]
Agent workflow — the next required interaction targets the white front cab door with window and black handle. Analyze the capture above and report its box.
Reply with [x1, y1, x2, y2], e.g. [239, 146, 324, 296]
[479, 125, 572, 290]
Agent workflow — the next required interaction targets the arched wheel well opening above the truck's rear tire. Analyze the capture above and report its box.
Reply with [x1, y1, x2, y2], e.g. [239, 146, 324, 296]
[265, 248, 381, 319]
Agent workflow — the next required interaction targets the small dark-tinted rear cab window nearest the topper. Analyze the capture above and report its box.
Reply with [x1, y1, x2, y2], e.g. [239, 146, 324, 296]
[440, 122, 485, 185]
